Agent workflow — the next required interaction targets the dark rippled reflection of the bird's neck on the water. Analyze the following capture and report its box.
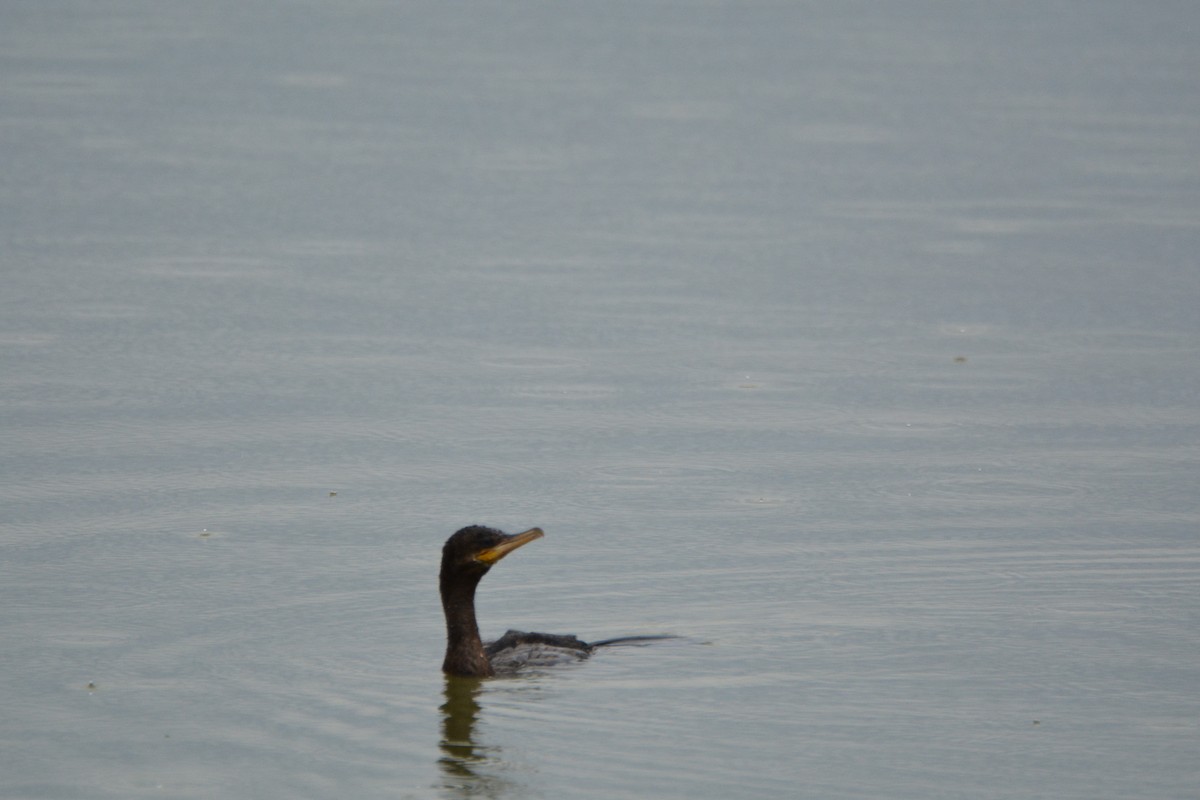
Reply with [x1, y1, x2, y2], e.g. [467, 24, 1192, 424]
[438, 675, 516, 798]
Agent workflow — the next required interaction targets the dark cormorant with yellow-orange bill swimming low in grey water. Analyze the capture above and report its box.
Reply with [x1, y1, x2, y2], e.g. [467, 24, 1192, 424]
[439, 525, 671, 678]
